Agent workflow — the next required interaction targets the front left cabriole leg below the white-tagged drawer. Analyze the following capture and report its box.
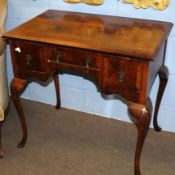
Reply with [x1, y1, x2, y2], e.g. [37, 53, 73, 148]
[10, 78, 27, 148]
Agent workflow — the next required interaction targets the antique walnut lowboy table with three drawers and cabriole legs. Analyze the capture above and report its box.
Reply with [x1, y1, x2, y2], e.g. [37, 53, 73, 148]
[3, 10, 172, 175]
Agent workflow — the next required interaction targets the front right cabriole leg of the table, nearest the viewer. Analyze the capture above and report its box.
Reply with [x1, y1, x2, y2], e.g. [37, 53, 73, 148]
[128, 98, 152, 175]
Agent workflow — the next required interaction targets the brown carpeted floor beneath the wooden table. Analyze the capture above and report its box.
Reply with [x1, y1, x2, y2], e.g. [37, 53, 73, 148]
[0, 100, 175, 175]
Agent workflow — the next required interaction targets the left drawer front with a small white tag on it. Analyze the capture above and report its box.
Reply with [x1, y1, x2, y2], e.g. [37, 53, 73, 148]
[11, 41, 45, 77]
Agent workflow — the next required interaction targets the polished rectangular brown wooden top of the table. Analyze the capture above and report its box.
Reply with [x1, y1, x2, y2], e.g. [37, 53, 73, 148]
[3, 10, 173, 60]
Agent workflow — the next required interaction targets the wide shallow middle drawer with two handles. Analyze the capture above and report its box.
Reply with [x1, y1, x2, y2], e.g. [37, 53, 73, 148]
[46, 46, 100, 69]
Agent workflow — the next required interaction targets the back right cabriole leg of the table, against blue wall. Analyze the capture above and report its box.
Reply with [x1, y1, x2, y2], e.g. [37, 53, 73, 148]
[153, 66, 169, 131]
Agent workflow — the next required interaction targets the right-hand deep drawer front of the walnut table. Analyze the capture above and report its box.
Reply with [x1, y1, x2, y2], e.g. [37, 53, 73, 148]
[102, 57, 143, 101]
